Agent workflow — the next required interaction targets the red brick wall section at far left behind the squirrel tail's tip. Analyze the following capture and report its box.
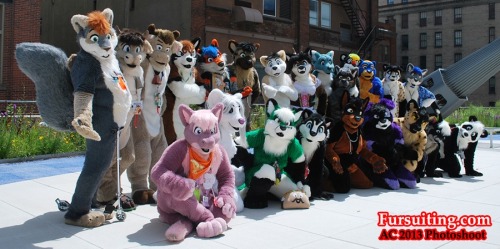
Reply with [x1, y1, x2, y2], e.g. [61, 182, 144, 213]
[0, 0, 41, 109]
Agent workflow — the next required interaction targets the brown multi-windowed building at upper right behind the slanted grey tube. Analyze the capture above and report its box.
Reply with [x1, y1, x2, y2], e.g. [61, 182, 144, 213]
[378, 0, 500, 106]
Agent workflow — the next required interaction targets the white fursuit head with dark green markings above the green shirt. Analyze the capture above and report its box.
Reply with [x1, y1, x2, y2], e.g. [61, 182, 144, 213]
[264, 99, 302, 155]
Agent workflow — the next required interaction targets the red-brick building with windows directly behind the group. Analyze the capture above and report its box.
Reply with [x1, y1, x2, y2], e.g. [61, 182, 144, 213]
[0, 0, 396, 109]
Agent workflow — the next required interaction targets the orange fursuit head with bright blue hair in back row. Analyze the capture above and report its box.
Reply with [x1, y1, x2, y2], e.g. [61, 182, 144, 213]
[199, 39, 228, 75]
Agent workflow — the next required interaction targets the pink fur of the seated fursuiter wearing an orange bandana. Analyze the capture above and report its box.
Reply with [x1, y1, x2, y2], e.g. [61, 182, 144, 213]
[151, 104, 236, 241]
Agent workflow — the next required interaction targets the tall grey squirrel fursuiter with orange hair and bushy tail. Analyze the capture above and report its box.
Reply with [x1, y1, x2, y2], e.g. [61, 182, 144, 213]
[16, 9, 131, 227]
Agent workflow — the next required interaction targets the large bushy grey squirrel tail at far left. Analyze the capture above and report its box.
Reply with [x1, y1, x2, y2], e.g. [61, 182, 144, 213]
[16, 42, 74, 131]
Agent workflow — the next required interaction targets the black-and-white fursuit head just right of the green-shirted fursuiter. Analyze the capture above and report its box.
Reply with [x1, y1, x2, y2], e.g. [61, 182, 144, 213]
[297, 109, 332, 163]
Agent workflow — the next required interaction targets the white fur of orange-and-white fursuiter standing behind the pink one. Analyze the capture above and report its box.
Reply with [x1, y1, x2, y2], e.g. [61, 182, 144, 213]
[168, 53, 206, 139]
